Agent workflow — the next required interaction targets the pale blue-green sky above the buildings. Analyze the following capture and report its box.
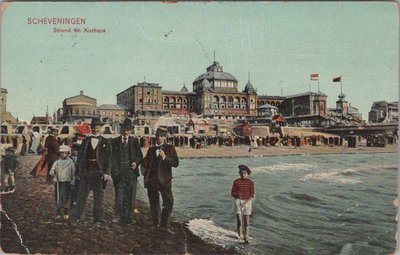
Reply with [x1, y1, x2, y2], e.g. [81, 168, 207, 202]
[1, 2, 399, 120]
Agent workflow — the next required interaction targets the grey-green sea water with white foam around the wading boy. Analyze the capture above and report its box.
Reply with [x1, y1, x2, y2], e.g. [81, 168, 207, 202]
[173, 153, 397, 255]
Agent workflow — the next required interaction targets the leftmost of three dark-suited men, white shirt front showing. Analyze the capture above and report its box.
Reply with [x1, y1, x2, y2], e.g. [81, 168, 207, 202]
[71, 118, 111, 224]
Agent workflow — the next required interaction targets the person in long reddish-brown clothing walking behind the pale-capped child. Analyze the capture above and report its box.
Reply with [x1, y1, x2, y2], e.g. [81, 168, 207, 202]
[30, 127, 60, 183]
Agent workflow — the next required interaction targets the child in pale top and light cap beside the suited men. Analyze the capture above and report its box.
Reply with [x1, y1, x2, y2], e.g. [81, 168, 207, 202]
[49, 145, 75, 220]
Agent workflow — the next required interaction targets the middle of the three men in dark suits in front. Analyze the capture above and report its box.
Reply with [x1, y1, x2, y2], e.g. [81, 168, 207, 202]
[111, 119, 143, 224]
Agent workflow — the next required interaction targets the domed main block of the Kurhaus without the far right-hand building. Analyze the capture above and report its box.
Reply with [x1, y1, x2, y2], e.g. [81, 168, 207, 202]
[117, 61, 284, 119]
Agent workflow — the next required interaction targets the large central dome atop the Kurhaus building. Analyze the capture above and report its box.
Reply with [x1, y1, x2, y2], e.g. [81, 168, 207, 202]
[193, 61, 238, 92]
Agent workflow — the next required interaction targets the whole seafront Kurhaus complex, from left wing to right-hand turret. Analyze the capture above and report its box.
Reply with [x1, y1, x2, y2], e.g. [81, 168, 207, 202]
[113, 61, 362, 126]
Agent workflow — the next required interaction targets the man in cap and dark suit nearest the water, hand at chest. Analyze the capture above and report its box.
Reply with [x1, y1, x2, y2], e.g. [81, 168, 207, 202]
[143, 128, 179, 232]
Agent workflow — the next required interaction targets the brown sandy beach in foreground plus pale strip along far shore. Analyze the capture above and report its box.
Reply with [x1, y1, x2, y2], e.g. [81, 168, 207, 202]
[1, 144, 397, 254]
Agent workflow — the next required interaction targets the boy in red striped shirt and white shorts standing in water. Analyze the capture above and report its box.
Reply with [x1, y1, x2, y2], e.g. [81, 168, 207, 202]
[231, 165, 255, 244]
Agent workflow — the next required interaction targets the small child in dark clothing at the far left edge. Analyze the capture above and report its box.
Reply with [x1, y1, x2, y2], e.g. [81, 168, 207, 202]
[1, 147, 18, 192]
